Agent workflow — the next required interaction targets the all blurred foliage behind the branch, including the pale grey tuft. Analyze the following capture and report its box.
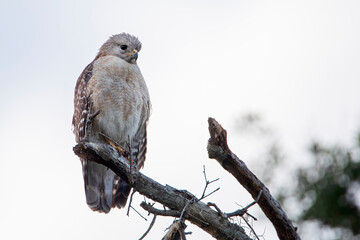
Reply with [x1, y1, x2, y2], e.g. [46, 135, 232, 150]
[235, 113, 360, 239]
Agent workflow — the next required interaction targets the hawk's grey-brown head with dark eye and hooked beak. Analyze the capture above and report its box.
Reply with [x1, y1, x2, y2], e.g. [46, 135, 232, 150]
[97, 33, 141, 63]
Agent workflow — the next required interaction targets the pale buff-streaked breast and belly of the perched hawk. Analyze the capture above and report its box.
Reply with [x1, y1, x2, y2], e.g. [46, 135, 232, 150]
[88, 57, 149, 145]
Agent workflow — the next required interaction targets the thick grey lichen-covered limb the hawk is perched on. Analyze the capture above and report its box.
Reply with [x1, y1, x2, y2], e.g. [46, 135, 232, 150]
[74, 142, 250, 240]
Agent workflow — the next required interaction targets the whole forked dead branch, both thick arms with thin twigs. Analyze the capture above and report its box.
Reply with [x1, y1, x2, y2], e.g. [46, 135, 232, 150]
[73, 118, 300, 240]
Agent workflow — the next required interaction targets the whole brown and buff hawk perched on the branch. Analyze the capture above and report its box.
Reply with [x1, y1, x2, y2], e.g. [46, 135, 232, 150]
[72, 33, 150, 213]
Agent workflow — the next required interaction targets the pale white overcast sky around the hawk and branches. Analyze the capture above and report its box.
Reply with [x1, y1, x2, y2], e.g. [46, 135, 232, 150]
[0, 0, 360, 240]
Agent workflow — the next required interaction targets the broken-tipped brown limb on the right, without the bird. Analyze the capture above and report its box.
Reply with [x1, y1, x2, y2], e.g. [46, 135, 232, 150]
[207, 118, 300, 240]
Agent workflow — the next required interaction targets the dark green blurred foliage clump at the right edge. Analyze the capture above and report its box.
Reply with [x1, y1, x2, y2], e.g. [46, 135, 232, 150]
[295, 135, 360, 235]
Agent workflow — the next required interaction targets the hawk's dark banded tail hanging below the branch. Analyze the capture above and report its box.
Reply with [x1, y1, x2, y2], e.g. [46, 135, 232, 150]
[82, 160, 131, 213]
